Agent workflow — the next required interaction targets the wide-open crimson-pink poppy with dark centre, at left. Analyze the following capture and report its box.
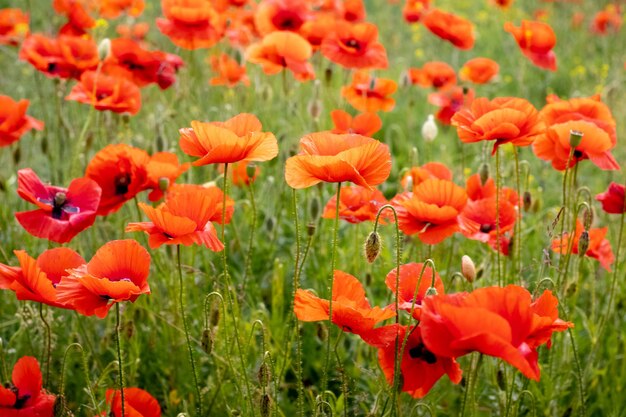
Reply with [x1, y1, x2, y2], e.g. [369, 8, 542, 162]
[15, 168, 102, 243]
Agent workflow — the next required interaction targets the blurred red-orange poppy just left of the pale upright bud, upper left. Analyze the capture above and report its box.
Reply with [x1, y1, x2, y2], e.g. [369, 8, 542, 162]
[19, 34, 99, 79]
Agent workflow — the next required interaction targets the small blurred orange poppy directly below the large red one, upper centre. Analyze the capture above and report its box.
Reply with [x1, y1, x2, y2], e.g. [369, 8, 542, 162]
[341, 70, 398, 112]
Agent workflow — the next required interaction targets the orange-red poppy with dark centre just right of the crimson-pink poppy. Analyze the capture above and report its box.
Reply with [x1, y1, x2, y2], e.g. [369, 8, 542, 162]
[85, 144, 150, 216]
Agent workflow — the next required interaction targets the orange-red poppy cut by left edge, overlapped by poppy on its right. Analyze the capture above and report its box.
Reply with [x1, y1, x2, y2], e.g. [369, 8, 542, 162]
[0, 248, 85, 308]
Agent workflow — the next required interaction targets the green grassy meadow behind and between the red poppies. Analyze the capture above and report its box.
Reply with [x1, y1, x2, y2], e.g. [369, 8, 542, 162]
[0, 0, 626, 417]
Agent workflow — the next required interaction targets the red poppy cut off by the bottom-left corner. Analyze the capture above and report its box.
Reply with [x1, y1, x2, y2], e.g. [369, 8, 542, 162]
[0, 356, 56, 417]
